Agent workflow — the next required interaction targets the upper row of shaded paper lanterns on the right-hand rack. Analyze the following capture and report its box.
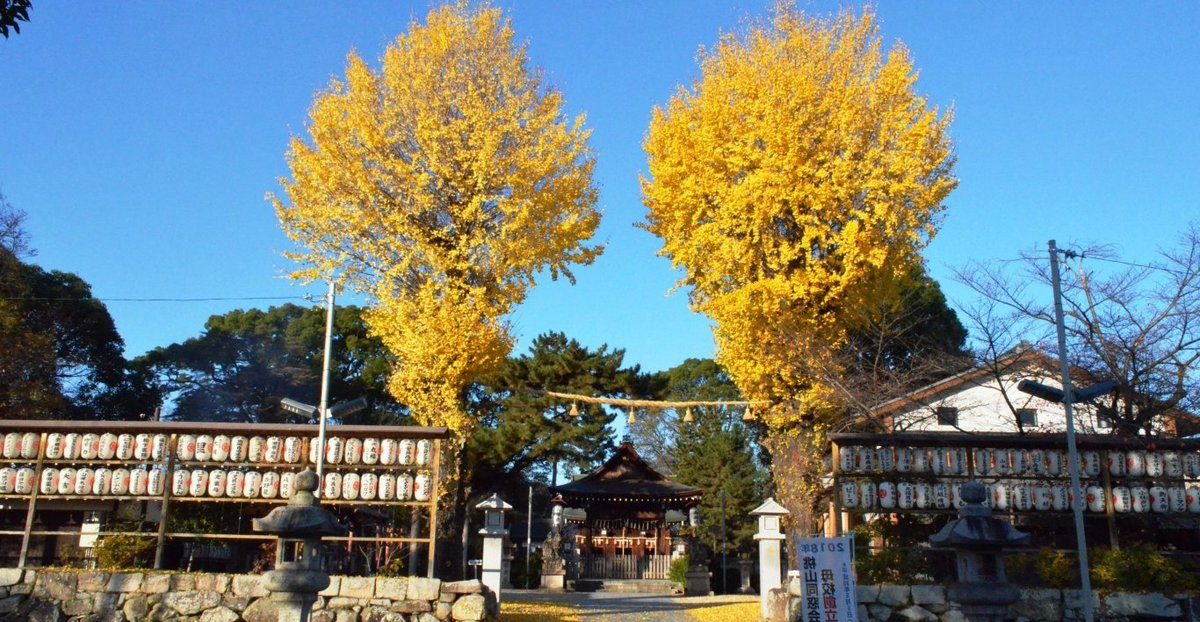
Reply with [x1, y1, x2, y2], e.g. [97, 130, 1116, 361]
[838, 447, 1200, 478]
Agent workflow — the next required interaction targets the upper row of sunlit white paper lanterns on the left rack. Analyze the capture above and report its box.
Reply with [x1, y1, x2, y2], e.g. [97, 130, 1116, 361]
[0, 432, 433, 466]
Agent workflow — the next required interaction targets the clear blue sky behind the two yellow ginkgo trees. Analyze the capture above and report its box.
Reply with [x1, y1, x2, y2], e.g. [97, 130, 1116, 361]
[0, 0, 1200, 370]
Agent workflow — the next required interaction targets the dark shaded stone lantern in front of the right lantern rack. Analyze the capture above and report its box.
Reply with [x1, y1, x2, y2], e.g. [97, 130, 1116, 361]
[929, 480, 1030, 622]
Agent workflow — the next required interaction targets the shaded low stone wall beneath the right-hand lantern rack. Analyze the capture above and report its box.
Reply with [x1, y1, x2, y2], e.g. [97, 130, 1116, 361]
[772, 585, 1200, 622]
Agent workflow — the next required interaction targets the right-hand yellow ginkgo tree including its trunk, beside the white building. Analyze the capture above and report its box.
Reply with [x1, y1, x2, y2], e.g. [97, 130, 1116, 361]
[642, 4, 956, 530]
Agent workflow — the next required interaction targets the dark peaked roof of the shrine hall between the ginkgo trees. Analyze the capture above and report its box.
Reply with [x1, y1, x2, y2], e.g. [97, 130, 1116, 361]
[551, 442, 704, 500]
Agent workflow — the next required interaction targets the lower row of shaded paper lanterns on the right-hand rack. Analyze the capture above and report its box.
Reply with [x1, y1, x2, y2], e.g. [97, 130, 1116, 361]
[841, 482, 1200, 514]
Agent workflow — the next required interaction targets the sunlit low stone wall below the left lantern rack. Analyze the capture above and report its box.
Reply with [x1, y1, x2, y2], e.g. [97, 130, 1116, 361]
[0, 568, 498, 622]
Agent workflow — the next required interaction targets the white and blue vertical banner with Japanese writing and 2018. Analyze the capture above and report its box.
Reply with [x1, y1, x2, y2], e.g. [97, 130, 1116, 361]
[796, 536, 858, 622]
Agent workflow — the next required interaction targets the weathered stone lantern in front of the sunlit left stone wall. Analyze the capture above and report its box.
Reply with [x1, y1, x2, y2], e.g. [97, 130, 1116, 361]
[253, 468, 348, 622]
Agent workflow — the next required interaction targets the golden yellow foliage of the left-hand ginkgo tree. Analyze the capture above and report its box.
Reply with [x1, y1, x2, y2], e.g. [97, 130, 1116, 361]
[270, 4, 602, 432]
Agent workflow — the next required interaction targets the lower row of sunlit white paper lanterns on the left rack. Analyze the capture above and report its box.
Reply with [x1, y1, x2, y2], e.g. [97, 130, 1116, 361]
[0, 467, 433, 501]
